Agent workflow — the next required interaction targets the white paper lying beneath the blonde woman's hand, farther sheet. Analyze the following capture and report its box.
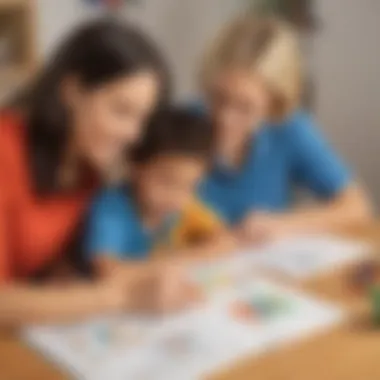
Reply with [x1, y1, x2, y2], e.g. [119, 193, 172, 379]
[254, 236, 370, 279]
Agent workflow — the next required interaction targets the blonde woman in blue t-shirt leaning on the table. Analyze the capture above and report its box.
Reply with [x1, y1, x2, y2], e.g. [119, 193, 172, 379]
[201, 16, 370, 240]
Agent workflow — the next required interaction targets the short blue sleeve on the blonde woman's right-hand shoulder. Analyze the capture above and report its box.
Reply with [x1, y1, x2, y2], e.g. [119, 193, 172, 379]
[286, 112, 351, 199]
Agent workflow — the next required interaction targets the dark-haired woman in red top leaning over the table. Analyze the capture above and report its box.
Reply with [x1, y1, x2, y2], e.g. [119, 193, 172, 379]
[0, 21, 183, 324]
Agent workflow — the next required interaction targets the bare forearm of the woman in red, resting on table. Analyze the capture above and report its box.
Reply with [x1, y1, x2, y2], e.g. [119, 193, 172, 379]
[0, 284, 120, 326]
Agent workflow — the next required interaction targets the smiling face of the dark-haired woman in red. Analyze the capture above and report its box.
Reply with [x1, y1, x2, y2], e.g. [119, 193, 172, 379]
[66, 71, 159, 170]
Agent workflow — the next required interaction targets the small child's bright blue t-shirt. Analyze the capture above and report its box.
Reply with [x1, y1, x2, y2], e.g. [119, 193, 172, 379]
[85, 186, 174, 260]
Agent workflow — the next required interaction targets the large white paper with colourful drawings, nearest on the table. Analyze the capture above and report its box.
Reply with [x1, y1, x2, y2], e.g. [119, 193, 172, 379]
[24, 276, 344, 380]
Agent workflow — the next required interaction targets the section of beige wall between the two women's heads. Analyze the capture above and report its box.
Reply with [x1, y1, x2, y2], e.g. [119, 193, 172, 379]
[122, 0, 240, 98]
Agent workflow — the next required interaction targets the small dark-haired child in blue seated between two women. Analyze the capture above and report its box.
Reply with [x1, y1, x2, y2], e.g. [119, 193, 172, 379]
[86, 109, 230, 276]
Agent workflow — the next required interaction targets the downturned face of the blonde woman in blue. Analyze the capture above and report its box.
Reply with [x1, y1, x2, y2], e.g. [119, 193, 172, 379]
[206, 69, 269, 149]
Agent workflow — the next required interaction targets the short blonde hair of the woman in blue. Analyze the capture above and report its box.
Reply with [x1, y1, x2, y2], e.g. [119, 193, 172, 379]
[201, 15, 303, 119]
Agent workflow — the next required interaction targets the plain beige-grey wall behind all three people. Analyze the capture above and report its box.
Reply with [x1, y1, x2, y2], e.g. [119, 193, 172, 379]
[2, 0, 380, 207]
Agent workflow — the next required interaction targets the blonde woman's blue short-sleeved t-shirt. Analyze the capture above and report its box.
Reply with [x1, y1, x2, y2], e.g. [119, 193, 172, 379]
[200, 111, 350, 224]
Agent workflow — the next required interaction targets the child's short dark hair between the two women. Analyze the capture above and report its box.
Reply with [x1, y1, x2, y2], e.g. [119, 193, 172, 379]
[131, 108, 214, 164]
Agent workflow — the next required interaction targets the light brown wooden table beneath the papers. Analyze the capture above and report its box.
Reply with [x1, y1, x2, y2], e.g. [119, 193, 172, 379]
[0, 226, 380, 380]
